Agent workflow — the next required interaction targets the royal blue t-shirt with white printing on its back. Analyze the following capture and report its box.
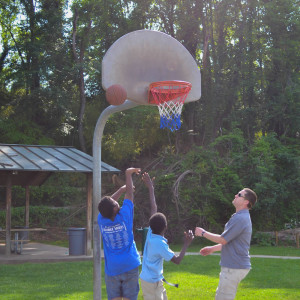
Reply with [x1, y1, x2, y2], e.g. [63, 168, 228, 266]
[98, 199, 141, 276]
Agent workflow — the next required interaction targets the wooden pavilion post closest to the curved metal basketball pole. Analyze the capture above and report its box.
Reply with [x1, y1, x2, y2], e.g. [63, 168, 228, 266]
[86, 173, 93, 256]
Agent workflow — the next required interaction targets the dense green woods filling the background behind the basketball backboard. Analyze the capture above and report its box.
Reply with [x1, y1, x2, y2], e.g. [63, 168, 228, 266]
[0, 0, 300, 233]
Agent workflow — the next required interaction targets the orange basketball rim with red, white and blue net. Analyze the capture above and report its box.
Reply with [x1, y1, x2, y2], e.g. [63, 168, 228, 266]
[148, 80, 192, 131]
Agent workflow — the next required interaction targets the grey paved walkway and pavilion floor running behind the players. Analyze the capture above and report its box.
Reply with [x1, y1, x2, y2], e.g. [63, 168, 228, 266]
[0, 242, 300, 264]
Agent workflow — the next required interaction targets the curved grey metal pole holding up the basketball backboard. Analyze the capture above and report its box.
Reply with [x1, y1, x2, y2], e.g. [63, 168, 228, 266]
[93, 100, 138, 300]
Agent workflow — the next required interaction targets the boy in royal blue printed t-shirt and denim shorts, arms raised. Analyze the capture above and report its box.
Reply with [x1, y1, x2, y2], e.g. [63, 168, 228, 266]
[98, 168, 141, 300]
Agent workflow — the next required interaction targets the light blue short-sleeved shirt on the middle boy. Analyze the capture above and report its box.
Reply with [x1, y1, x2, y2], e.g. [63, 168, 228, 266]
[140, 227, 174, 283]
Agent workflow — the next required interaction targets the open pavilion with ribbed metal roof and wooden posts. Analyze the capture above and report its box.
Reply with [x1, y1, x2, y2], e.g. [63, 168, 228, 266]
[0, 144, 120, 255]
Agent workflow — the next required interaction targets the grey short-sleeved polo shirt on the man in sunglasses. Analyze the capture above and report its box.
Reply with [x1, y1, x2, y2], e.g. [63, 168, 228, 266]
[220, 209, 252, 269]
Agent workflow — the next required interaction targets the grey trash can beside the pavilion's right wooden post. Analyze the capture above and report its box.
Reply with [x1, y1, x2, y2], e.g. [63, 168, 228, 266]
[68, 228, 86, 255]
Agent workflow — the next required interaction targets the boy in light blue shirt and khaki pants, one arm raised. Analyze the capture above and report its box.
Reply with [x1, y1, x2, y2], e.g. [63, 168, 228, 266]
[140, 173, 194, 300]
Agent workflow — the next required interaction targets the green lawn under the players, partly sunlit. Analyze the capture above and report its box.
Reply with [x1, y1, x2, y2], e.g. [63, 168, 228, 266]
[0, 255, 300, 300]
